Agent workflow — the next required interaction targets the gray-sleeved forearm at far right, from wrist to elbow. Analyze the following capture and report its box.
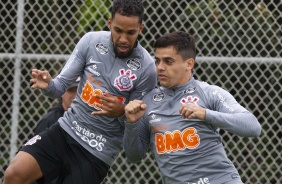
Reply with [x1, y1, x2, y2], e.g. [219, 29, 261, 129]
[206, 109, 261, 137]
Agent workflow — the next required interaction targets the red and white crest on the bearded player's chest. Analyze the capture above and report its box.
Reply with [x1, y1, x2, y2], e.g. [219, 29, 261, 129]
[114, 69, 137, 91]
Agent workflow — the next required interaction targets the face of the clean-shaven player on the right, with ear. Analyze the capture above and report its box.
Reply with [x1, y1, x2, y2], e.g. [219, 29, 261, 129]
[155, 47, 194, 88]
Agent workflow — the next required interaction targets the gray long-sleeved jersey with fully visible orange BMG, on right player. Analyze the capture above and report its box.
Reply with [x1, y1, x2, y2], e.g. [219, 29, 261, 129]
[124, 78, 261, 184]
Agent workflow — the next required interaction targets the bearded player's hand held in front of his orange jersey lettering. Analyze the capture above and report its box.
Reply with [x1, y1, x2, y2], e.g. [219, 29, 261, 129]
[91, 91, 124, 117]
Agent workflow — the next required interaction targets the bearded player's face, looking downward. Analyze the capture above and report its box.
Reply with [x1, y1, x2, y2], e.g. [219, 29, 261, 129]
[108, 13, 144, 58]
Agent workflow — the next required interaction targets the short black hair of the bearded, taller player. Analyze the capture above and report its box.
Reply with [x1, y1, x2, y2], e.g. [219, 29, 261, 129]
[112, 0, 144, 23]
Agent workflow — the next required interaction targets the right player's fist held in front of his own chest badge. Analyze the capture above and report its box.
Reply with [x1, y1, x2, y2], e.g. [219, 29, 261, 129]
[179, 103, 206, 120]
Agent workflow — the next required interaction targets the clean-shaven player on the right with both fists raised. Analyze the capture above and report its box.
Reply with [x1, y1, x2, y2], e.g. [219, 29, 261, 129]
[124, 31, 261, 184]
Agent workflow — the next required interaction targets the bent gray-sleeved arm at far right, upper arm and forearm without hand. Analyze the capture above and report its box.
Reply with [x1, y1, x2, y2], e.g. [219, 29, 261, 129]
[205, 87, 261, 137]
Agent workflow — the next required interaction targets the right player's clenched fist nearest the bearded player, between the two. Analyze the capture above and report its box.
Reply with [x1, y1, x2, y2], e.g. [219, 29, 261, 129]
[124, 100, 147, 123]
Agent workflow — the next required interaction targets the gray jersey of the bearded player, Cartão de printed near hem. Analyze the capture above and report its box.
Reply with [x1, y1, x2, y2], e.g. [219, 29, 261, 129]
[42, 31, 157, 165]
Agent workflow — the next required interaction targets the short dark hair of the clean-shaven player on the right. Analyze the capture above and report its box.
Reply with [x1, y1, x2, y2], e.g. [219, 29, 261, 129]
[155, 31, 196, 60]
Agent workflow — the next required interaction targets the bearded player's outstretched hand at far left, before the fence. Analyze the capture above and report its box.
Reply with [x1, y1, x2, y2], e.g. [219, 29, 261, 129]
[30, 69, 51, 89]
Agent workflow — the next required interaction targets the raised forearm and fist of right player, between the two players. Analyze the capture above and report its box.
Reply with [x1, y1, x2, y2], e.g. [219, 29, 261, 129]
[123, 100, 150, 163]
